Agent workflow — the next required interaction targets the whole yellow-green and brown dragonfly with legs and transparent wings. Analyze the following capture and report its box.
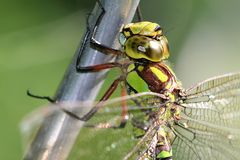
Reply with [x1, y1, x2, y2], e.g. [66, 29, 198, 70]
[23, 1, 240, 160]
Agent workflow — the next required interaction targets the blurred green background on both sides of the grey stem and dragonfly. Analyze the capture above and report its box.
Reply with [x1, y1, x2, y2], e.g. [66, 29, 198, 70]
[0, 0, 240, 160]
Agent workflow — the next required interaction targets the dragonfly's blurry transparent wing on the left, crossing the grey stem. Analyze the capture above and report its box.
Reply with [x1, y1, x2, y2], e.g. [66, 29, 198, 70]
[21, 93, 165, 160]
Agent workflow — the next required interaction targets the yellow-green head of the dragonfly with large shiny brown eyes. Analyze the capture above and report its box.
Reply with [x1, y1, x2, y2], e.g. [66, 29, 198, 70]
[119, 22, 169, 62]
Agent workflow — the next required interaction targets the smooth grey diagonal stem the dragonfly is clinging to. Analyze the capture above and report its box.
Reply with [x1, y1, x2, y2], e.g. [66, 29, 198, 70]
[24, 0, 139, 160]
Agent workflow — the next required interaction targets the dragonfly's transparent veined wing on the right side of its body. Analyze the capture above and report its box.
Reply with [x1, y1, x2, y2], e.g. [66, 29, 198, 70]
[173, 73, 240, 160]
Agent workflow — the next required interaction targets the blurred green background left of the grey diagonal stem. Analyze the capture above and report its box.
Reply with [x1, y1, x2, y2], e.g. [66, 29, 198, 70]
[0, 0, 94, 160]
